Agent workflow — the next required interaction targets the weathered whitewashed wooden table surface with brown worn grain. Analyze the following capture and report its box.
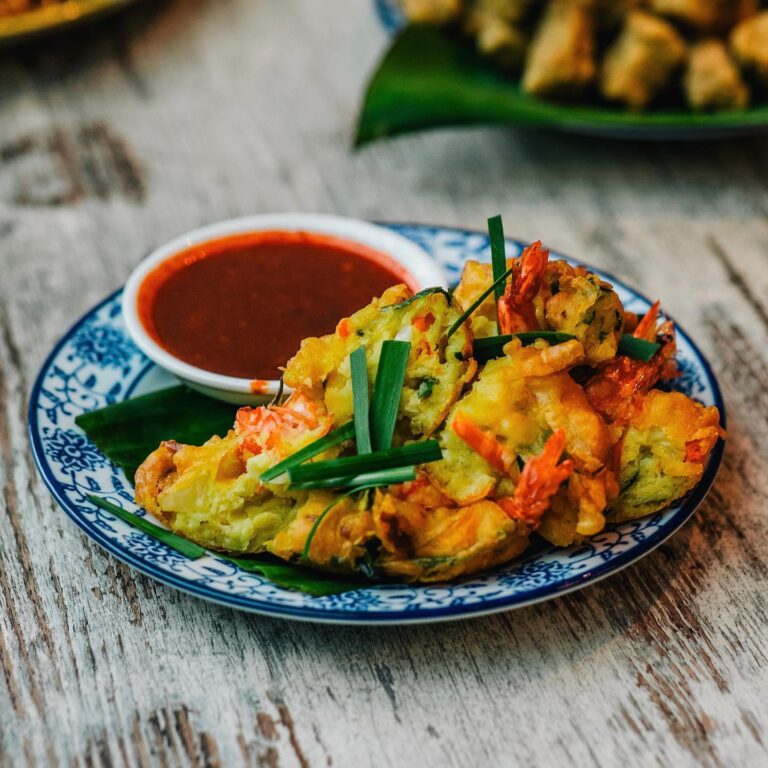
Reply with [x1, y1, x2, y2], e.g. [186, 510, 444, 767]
[0, 0, 768, 768]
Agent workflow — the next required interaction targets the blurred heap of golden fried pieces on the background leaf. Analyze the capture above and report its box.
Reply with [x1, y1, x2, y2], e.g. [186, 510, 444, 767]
[402, 0, 768, 111]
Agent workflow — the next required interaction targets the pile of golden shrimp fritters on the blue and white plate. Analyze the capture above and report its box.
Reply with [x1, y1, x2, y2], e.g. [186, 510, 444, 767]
[136, 243, 724, 582]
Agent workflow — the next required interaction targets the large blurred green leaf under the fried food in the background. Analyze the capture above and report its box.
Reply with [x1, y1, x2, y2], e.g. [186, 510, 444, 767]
[356, 25, 768, 145]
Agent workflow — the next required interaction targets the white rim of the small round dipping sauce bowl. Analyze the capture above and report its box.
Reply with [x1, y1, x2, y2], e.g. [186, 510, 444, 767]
[122, 213, 448, 397]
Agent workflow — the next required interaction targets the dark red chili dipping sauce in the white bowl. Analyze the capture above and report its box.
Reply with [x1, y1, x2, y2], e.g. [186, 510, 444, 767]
[138, 232, 415, 379]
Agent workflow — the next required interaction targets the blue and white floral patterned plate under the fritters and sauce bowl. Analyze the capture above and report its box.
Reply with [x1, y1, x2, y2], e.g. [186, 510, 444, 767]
[29, 224, 725, 624]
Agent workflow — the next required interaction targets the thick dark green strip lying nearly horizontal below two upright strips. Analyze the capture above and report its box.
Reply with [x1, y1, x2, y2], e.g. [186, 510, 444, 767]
[288, 440, 443, 487]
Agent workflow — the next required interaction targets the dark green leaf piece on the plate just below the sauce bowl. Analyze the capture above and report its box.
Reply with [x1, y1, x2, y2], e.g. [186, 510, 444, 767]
[75, 387, 237, 480]
